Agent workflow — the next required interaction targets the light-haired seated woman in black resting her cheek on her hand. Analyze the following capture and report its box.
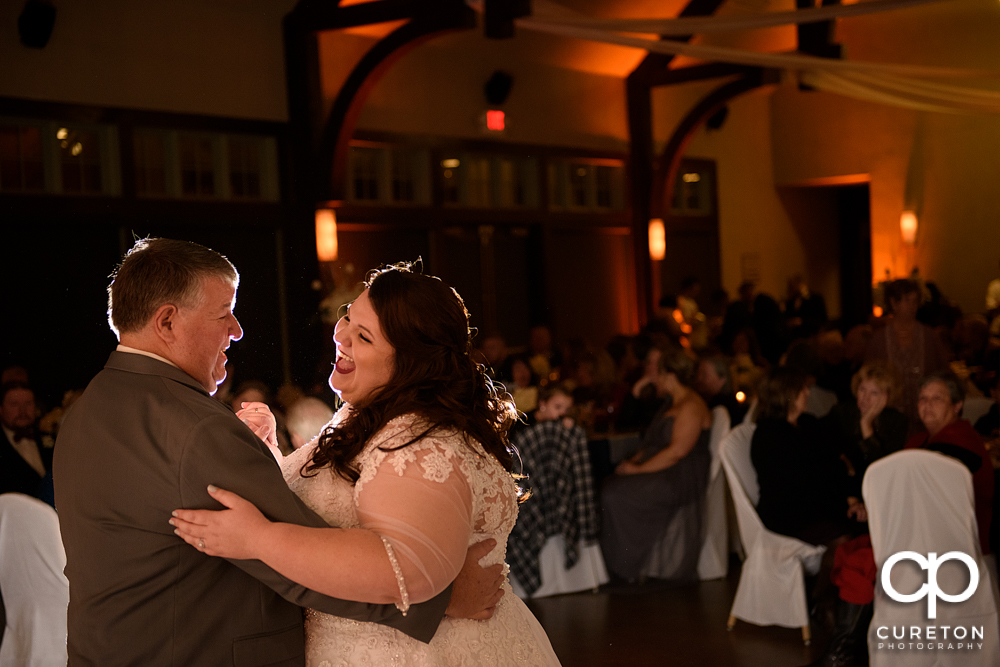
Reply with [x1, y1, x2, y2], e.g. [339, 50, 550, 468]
[824, 361, 907, 480]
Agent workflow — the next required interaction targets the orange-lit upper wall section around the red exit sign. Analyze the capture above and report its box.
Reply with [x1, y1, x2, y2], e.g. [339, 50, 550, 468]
[322, 30, 628, 151]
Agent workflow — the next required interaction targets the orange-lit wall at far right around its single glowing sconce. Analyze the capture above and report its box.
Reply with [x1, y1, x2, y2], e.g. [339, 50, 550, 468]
[771, 0, 1000, 312]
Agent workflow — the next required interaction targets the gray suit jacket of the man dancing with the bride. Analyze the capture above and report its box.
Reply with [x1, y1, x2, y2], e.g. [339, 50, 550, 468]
[54, 352, 451, 667]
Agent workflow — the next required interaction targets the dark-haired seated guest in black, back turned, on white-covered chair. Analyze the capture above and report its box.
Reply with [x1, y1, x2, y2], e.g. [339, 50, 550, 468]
[750, 367, 866, 544]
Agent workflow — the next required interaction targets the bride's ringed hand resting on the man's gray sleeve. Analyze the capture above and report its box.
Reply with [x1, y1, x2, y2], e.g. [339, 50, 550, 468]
[170, 486, 273, 560]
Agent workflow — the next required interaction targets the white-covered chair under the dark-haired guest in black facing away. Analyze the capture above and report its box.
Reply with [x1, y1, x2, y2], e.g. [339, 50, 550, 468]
[721, 424, 826, 644]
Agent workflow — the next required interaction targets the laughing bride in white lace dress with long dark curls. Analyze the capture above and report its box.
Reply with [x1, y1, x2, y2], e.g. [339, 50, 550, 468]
[173, 265, 559, 667]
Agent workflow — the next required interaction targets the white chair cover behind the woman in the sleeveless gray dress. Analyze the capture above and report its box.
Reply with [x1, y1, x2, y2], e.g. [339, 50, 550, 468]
[698, 405, 729, 581]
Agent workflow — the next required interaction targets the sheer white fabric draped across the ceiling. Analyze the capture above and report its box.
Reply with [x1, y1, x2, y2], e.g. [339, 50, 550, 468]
[516, 0, 1000, 113]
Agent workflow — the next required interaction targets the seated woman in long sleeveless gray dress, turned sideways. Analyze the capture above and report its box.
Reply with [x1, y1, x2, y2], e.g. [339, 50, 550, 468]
[601, 350, 712, 581]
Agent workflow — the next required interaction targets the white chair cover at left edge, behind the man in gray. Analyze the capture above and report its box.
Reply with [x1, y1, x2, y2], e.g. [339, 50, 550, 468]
[0, 493, 69, 667]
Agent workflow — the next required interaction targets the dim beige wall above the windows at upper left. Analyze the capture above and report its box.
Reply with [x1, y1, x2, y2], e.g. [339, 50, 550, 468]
[0, 0, 295, 121]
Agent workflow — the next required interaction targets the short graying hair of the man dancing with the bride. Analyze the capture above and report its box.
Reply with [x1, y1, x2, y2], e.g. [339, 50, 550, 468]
[108, 238, 240, 338]
